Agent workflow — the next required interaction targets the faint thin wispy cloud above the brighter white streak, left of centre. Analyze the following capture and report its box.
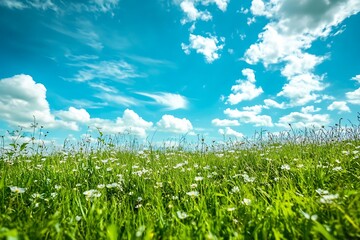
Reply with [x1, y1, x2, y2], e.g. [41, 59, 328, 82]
[71, 61, 142, 82]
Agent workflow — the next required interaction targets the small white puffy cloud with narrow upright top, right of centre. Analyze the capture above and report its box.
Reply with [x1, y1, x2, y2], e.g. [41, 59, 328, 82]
[226, 68, 264, 105]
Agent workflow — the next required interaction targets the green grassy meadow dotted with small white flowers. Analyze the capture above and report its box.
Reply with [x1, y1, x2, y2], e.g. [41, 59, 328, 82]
[0, 121, 360, 240]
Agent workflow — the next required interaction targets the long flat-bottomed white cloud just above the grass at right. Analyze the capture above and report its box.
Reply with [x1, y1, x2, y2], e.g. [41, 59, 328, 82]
[275, 112, 330, 128]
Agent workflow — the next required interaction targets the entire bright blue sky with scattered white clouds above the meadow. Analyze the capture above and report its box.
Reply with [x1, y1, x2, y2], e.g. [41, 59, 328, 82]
[0, 0, 360, 145]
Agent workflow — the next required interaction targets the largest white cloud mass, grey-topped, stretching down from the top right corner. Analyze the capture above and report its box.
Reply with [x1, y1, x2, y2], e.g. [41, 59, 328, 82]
[245, 0, 360, 106]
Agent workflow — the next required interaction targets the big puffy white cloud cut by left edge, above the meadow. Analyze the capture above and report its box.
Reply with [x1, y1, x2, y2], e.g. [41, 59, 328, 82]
[0, 74, 78, 130]
